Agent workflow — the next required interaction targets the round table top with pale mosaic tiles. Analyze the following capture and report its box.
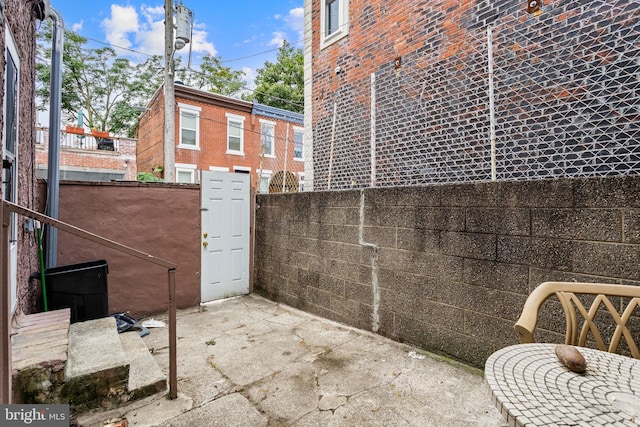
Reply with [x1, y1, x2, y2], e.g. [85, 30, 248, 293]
[484, 343, 640, 427]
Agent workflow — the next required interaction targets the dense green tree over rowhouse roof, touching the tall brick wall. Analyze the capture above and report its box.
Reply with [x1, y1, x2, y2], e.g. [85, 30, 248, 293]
[245, 40, 304, 113]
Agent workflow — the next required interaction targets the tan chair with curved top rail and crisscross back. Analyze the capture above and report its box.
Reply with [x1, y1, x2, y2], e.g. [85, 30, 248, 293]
[515, 282, 640, 359]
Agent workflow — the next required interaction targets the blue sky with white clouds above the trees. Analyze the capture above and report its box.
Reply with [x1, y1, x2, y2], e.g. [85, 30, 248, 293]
[51, 0, 303, 87]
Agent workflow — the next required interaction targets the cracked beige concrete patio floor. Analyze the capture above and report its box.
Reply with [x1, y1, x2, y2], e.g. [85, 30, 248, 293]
[78, 295, 506, 427]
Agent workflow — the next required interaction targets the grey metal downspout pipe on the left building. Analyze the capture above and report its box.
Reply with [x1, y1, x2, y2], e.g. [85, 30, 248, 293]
[45, 8, 64, 268]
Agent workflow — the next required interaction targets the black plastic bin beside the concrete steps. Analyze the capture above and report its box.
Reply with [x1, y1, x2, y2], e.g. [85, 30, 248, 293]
[44, 260, 109, 323]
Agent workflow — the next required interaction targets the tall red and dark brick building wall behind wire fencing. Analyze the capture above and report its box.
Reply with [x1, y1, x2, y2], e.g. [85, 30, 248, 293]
[305, 0, 640, 189]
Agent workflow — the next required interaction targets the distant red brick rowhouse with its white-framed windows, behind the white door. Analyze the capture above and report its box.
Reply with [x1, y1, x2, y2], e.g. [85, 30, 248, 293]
[137, 84, 304, 192]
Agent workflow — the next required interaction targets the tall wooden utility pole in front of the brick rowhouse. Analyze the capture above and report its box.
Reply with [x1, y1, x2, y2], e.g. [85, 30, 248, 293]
[162, 0, 176, 182]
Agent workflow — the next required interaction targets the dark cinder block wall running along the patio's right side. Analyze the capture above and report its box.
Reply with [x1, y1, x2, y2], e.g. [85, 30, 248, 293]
[254, 177, 640, 367]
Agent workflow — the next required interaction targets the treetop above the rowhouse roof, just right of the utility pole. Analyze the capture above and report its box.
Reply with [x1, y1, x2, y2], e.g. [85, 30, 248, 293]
[176, 55, 245, 96]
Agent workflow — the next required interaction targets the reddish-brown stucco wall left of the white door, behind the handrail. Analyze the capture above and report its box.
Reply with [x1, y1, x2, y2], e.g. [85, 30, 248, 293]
[58, 182, 200, 316]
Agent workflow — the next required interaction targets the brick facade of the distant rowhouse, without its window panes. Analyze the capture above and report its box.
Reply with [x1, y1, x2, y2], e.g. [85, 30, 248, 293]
[137, 84, 304, 188]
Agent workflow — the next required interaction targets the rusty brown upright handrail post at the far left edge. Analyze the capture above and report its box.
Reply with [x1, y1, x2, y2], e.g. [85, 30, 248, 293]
[0, 201, 11, 405]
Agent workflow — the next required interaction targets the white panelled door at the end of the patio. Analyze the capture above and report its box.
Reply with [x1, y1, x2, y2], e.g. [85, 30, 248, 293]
[200, 171, 251, 302]
